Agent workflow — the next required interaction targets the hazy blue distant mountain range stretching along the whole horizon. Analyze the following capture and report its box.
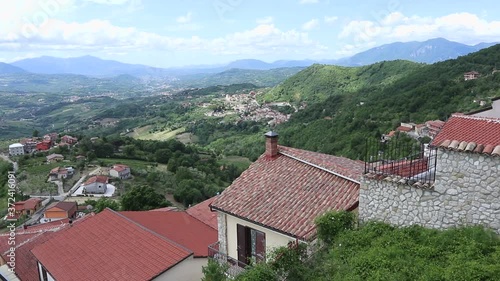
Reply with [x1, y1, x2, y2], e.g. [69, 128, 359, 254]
[0, 38, 496, 77]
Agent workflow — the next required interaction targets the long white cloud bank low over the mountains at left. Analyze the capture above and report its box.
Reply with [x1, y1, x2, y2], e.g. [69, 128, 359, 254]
[0, 19, 326, 56]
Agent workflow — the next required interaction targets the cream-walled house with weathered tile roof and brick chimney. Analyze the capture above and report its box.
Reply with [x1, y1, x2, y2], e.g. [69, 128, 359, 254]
[210, 132, 364, 266]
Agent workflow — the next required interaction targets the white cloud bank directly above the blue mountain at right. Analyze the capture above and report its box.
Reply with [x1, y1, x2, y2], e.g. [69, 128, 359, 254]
[338, 12, 500, 55]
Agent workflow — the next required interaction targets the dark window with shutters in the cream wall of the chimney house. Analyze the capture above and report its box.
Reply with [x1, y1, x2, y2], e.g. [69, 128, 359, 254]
[237, 224, 266, 266]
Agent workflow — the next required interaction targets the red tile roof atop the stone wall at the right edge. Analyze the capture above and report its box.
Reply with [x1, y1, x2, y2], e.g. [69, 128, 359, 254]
[432, 114, 500, 156]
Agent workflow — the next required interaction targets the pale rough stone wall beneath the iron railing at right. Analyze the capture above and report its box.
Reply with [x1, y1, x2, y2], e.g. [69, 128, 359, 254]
[359, 149, 500, 233]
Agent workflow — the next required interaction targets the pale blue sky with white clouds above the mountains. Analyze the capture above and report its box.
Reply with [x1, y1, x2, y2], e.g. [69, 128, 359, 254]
[0, 0, 500, 67]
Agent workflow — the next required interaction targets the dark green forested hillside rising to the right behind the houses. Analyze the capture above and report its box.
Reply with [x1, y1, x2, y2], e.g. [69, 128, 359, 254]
[273, 45, 500, 158]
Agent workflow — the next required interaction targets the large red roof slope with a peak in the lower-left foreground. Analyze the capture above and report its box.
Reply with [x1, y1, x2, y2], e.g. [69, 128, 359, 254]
[32, 209, 192, 281]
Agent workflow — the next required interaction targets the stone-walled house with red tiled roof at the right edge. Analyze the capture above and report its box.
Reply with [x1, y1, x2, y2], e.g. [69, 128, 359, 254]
[359, 114, 500, 234]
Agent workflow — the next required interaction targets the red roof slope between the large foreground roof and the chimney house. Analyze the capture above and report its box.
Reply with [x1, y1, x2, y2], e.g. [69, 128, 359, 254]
[120, 211, 217, 257]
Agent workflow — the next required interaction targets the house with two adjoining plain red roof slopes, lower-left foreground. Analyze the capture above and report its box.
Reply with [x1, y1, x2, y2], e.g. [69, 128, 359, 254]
[31, 209, 217, 281]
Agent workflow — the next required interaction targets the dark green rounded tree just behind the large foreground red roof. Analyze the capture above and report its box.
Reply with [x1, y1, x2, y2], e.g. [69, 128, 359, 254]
[121, 185, 172, 211]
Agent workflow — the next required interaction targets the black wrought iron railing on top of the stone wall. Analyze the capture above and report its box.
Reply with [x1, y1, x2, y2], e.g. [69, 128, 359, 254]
[365, 138, 437, 185]
